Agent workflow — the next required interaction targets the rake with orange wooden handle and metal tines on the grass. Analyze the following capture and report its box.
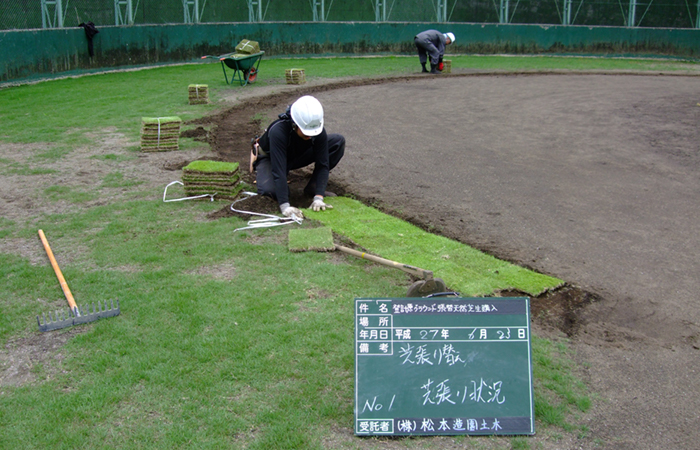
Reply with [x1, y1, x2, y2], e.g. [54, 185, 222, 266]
[36, 230, 120, 331]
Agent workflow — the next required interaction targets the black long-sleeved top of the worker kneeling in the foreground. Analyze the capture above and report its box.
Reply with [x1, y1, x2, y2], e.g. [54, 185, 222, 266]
[259, 119, 330, 205]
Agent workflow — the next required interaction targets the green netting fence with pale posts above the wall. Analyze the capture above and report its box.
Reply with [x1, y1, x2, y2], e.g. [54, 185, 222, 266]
[0, 0, 700, 30]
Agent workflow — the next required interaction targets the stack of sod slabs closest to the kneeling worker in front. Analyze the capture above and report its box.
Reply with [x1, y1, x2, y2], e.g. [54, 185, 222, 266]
[182, 161, 243, 200]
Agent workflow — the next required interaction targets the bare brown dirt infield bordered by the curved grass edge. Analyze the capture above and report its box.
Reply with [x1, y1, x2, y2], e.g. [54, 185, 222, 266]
[212, 74, 700, 449]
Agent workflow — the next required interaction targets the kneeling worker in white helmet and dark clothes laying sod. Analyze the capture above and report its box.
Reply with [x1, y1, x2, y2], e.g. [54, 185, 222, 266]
[253, 95, 345, 217]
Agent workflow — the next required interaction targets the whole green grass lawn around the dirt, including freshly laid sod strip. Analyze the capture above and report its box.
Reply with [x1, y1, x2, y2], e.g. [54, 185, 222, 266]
[0, 56, 698, 449]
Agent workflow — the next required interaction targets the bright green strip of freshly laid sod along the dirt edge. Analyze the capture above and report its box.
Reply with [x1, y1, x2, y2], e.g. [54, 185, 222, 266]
[304, 197, 564, 296]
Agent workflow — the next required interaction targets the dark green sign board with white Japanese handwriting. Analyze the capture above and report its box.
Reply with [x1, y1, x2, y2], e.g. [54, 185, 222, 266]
[355, 297, 535, 436]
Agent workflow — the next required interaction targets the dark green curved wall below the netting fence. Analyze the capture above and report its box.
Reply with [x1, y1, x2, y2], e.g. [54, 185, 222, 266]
[0, 22, 700, 82]
